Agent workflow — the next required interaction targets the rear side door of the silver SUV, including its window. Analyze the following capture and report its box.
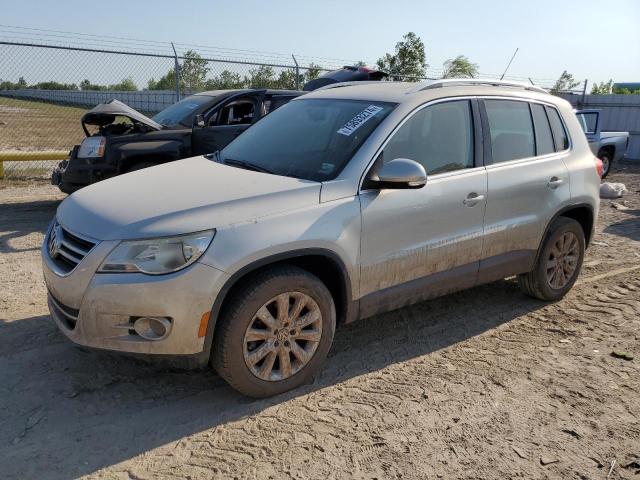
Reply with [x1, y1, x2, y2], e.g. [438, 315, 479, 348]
[479, 98, 570, 282]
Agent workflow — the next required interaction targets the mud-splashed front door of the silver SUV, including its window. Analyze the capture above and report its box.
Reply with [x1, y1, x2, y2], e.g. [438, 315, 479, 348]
[360, 100, 487, 316]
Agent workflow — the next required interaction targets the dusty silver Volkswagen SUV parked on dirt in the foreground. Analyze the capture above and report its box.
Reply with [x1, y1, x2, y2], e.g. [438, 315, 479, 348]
[42, 80, 602, 397]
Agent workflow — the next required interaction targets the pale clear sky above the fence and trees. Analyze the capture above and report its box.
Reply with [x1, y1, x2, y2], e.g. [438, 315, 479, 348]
[0, 0, 640, 88]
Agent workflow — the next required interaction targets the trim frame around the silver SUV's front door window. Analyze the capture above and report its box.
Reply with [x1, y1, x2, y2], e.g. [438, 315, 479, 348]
[358, 95, 486, 193]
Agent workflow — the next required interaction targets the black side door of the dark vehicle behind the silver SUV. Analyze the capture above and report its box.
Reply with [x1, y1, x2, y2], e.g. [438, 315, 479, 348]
[191, 90, 265, 155]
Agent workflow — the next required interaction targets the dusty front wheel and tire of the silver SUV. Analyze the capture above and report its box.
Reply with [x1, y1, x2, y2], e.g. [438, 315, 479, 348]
[212, 266, 336, 398]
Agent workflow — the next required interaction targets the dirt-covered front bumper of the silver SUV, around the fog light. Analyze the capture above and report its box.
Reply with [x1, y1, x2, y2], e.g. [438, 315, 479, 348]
[41, 226, 228, 355]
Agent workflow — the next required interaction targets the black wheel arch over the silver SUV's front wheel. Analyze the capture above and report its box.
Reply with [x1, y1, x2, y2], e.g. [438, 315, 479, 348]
[203, 248, 358, 364]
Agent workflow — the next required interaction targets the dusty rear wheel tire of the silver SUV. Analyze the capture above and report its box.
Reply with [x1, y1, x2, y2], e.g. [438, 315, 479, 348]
[518, 217, 585, 301]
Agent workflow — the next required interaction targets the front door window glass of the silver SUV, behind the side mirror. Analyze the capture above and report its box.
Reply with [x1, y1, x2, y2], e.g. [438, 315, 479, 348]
[384, 100, 474, 175]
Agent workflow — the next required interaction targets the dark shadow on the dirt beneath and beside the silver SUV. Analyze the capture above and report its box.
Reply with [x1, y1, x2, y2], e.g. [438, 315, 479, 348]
[0, 280, 545, 478]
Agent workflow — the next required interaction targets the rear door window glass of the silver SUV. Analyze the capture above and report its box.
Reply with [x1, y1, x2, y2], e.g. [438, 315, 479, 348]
[484, 100, 535, 163]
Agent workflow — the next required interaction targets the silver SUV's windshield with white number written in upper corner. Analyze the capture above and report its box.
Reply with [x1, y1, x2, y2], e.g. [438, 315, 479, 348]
[220, 99, 395, 182]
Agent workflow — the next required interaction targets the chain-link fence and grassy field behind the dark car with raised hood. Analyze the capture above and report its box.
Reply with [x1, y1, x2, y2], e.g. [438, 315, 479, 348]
[0, 37, 560, 178]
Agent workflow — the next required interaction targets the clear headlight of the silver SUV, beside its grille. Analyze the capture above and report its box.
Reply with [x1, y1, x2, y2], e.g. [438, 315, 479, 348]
[98, 230, 216, 275]
